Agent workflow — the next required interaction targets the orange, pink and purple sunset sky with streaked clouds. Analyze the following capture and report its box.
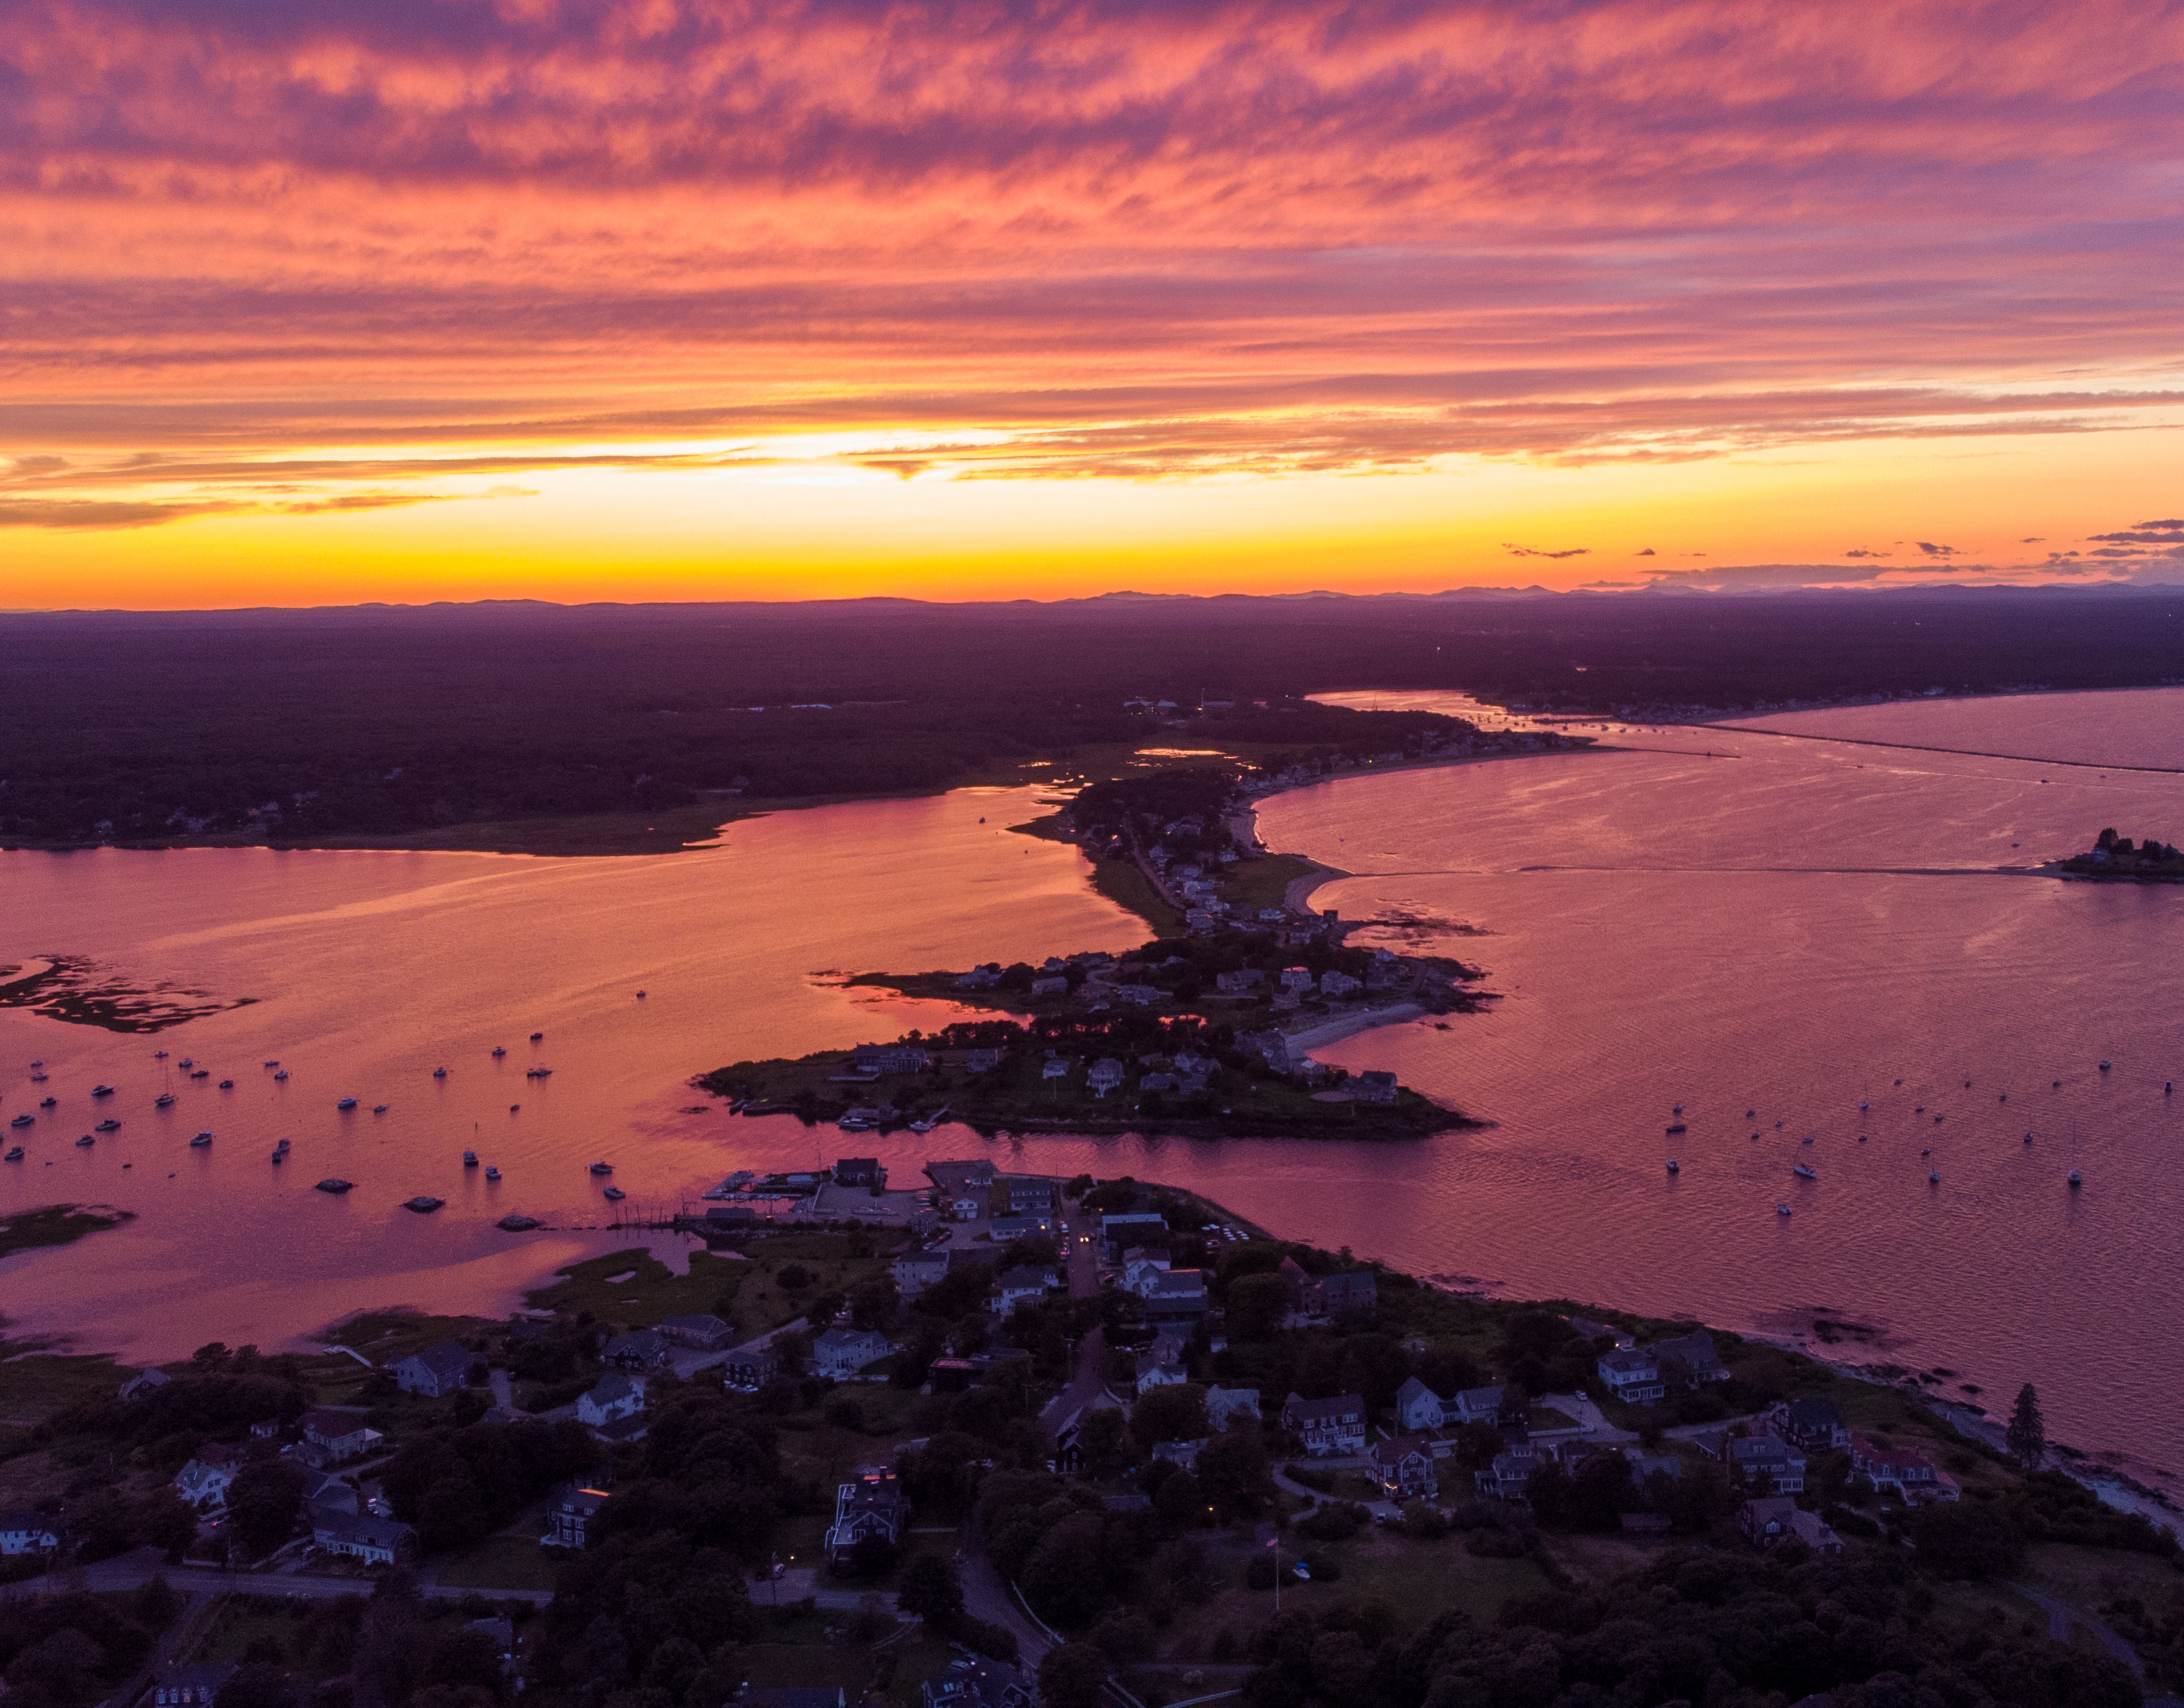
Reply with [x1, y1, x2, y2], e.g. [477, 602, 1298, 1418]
[0, 0, 2184, 607]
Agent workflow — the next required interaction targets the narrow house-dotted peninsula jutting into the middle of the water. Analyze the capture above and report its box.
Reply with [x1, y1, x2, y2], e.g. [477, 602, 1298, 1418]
[692, 746, 1574, 1138]
